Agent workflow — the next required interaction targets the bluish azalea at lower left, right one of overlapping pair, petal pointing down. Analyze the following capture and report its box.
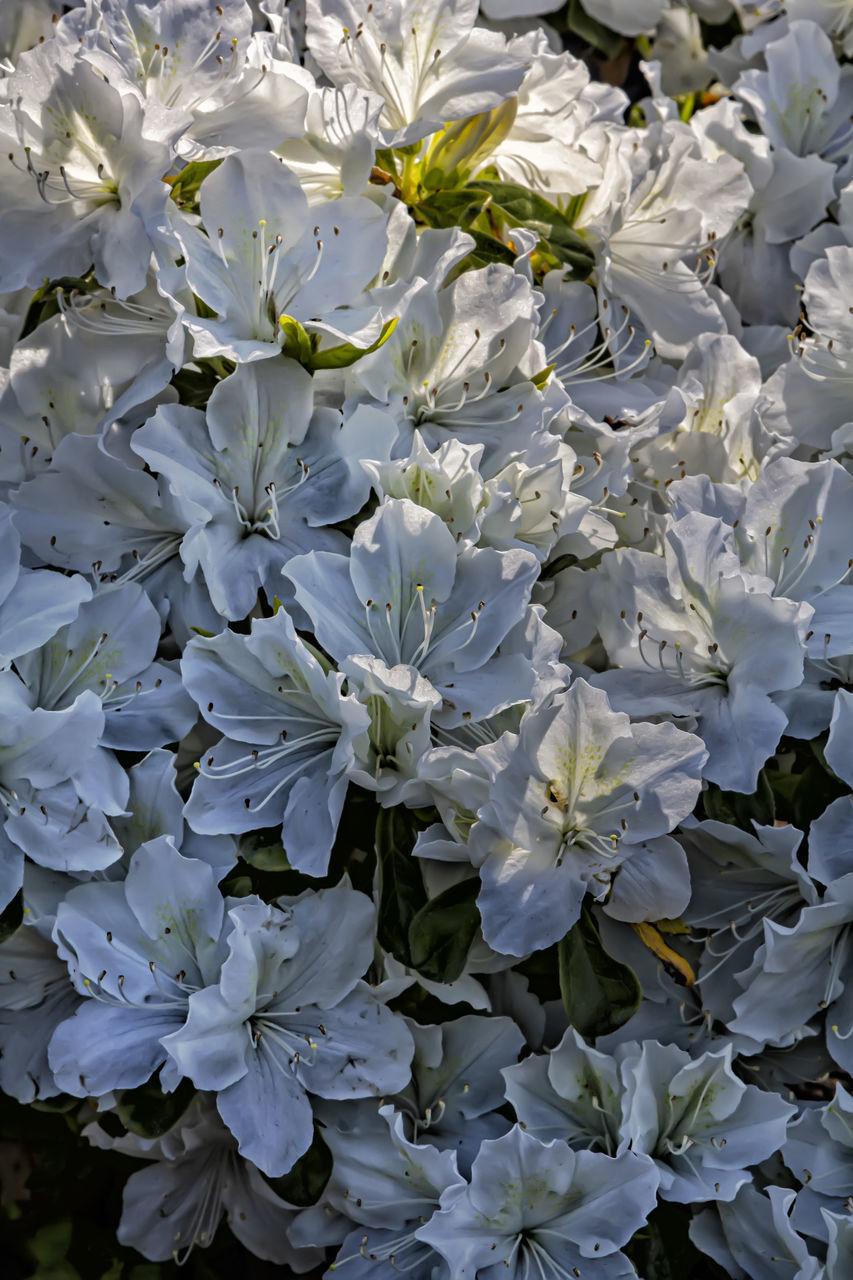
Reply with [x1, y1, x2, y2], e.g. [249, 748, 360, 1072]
[165, 884, 412, 1176]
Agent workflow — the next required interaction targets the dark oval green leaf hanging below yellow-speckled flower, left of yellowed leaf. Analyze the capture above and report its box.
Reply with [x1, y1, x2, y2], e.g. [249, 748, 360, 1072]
[557, 908, 643, 1038]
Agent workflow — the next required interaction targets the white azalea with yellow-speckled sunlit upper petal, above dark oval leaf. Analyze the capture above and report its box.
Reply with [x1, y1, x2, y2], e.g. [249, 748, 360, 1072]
[467, 680, 706, 955]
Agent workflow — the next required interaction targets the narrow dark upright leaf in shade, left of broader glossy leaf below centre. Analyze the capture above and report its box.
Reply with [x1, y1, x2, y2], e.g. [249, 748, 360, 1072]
[375, 805, 427, 965]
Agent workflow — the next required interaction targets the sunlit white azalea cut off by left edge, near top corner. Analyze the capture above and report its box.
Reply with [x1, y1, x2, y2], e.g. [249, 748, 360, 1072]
[0, 37, 186, 298]
